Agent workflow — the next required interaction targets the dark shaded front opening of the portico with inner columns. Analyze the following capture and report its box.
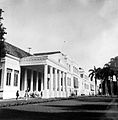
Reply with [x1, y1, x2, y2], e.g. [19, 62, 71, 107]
[20, 66, 43, 92]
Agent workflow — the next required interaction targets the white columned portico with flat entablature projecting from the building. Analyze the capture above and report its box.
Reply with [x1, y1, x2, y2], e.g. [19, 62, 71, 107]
[20, 56, 67, 98]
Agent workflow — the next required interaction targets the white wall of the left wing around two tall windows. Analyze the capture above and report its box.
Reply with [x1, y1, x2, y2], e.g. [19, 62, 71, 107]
[3, 55, 20, 99]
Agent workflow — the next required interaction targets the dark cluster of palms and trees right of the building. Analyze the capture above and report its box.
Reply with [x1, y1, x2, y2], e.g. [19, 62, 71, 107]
[89, 57, 118, 96]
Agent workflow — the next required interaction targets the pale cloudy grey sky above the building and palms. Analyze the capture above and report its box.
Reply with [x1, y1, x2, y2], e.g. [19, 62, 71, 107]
[0, 0, 118, 72]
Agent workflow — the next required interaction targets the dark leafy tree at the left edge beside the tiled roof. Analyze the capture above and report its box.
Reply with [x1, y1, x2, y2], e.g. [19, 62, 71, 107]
[0, 9, 7, 59]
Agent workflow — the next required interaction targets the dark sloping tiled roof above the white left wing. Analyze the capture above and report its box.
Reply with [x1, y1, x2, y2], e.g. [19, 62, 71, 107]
[5, 42, 31, 58]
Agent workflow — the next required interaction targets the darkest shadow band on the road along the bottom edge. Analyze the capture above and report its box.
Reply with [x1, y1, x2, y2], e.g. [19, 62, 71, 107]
[0, 109, 103, 120]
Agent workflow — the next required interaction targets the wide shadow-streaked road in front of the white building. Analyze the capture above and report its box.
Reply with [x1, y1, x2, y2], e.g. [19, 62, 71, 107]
[0, 97, 118, 120]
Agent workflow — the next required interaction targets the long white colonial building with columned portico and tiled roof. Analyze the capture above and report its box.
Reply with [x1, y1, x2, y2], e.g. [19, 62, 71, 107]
[0, 42, 94, 99]
